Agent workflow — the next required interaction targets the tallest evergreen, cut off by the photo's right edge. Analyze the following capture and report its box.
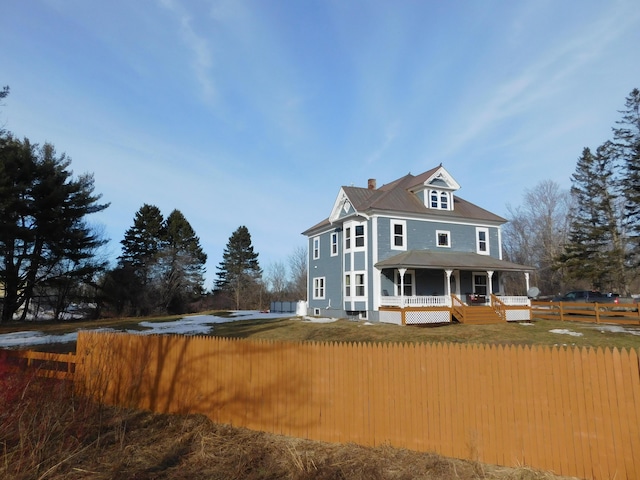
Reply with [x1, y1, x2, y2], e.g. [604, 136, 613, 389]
[613, 88, 640, 268]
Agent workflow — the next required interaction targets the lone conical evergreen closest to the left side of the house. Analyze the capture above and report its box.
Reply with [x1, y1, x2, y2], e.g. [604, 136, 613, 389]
[215, 226, 262, 310]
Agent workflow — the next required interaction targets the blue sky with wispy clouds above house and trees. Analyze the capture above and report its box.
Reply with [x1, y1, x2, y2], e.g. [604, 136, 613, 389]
[0, 0, 640, 287]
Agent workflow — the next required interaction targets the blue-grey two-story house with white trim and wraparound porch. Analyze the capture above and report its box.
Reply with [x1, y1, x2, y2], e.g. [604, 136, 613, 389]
[303, 165, 533, 324]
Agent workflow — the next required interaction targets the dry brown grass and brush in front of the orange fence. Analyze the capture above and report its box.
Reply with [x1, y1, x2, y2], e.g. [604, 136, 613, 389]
[0, 362, 580, 480]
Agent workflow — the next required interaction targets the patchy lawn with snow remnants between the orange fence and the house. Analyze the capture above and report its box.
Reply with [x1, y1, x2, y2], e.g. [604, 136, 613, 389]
[0, 312, 640, 352]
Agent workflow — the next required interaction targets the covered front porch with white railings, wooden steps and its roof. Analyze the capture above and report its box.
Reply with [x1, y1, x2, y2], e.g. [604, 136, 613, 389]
[375, 250, 533, 325]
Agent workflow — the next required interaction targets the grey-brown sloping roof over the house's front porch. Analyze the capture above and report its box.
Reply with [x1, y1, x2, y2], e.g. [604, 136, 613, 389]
[375, 250, 535, 272]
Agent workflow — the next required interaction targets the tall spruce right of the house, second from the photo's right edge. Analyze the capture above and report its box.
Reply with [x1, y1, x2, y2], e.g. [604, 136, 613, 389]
[559, 142, 626, 290]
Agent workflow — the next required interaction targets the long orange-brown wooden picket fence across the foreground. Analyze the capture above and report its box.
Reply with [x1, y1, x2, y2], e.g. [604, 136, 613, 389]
[76, 332, 640, 480]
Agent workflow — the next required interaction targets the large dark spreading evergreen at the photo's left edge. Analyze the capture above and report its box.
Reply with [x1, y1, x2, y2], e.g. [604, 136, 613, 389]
[0, 133, 108, 322]
